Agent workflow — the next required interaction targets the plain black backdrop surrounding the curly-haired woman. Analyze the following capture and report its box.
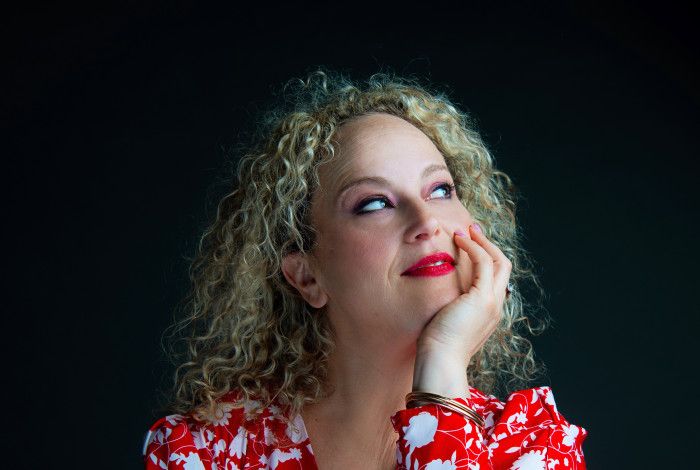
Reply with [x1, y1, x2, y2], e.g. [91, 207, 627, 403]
[2, 1, 700, 468]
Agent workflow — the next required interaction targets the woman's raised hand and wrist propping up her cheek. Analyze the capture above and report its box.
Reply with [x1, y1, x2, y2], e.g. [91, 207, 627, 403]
[413, 224, 512, 398]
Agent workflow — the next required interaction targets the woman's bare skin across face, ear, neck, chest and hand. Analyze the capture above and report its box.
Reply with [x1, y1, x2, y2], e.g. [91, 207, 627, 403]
[282, 114, 511, 469]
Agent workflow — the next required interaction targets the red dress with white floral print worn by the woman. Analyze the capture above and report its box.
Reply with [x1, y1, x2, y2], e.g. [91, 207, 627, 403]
[143, 387, 587, 470]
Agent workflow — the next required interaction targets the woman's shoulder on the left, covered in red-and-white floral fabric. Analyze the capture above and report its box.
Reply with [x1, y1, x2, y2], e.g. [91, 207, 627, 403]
[143, 393, 307, 468]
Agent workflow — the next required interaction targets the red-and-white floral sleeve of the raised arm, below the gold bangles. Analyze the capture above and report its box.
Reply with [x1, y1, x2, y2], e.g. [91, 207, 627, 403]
[391, 387, 587, 470]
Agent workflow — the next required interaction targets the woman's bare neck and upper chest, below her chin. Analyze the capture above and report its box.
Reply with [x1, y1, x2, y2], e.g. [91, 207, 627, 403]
[302, 334, 415, 469]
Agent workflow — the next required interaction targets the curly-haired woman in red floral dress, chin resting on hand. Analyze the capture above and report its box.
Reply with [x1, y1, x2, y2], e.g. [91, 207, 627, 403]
[144, 72, 586, 470]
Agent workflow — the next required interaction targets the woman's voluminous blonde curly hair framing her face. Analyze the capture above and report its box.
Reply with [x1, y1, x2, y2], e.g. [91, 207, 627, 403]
[163, 70, 545, 420]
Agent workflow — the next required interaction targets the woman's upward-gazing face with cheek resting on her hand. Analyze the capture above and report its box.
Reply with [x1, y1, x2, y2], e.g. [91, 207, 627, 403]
[310, 114, 473, 341]
